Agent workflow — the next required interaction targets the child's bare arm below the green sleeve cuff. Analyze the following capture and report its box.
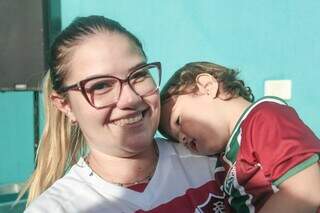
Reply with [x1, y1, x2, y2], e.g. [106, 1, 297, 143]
[260, 163, 320, 213]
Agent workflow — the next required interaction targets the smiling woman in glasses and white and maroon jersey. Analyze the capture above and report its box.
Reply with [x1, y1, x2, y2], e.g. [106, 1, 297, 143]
[26, 16, 225, 213]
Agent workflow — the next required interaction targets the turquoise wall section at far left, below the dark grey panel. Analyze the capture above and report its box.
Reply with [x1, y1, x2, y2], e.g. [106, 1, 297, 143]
[0, 92, 34, 185]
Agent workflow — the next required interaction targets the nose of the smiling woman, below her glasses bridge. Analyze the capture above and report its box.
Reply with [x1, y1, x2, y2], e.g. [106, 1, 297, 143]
[117, 84, 142, 109]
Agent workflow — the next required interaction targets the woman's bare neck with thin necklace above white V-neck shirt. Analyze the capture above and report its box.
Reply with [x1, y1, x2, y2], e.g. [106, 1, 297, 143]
[86, 143, 158, 186]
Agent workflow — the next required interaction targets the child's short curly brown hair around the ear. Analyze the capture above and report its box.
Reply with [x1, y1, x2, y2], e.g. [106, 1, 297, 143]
[160, 62, 254, 104]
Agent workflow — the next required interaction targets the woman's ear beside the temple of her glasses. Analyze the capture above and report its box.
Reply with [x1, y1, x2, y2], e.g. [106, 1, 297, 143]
[50, 92, 77, 123]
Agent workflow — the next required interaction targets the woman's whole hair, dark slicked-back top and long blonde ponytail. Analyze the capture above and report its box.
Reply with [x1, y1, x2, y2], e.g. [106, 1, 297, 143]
[19, 16, 146, 205]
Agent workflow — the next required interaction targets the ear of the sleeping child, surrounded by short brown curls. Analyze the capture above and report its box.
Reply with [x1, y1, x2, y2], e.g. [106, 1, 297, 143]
[196, 73, 219, 98]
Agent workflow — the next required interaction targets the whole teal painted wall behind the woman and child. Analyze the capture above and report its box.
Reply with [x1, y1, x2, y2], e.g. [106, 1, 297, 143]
[0, 0, 320, 184]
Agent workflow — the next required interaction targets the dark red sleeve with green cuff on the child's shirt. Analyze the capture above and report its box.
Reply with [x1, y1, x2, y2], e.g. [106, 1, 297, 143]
[242, 102, 320, 186]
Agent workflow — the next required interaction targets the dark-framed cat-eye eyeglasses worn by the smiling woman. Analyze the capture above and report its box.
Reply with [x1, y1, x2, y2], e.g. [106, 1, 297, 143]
[59, 62, 161, 109]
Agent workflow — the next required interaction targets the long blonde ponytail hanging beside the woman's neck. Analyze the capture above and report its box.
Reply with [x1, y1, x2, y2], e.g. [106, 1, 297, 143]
[19, 72, 86, 205]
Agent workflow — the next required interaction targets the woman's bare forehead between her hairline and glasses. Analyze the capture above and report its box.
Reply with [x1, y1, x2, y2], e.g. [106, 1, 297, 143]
[65, 33, 145, 80]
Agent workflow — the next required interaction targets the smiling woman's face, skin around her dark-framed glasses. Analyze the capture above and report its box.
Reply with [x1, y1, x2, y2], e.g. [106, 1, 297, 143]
[64, 33, 160, 157]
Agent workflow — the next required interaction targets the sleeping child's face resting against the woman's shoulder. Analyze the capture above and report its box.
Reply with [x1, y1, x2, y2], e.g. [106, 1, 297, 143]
[160, 94, 229, 155]
